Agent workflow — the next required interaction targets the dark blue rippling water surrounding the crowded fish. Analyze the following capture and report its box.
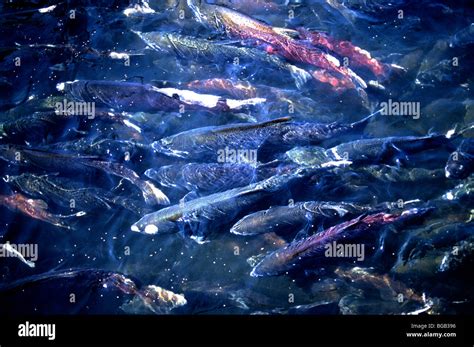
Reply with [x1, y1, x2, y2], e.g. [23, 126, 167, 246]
[0, 0, 474, 314]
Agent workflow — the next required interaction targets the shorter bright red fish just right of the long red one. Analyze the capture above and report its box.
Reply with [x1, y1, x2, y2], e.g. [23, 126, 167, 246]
[298, 28, 390, 78]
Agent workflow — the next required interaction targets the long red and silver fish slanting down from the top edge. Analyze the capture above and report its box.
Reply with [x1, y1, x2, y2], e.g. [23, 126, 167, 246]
[187, 0, 366, 88]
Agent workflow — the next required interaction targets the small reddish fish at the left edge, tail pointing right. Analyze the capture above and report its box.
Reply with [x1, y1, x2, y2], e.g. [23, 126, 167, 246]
[0, 194, 85, 229]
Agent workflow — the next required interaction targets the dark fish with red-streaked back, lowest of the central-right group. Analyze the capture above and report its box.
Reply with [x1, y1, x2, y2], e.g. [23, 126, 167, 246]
[250, 208, 434, 277]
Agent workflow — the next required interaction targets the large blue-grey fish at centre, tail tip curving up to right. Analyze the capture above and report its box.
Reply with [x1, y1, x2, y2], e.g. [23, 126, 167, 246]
[152, 112, 378, 162]
